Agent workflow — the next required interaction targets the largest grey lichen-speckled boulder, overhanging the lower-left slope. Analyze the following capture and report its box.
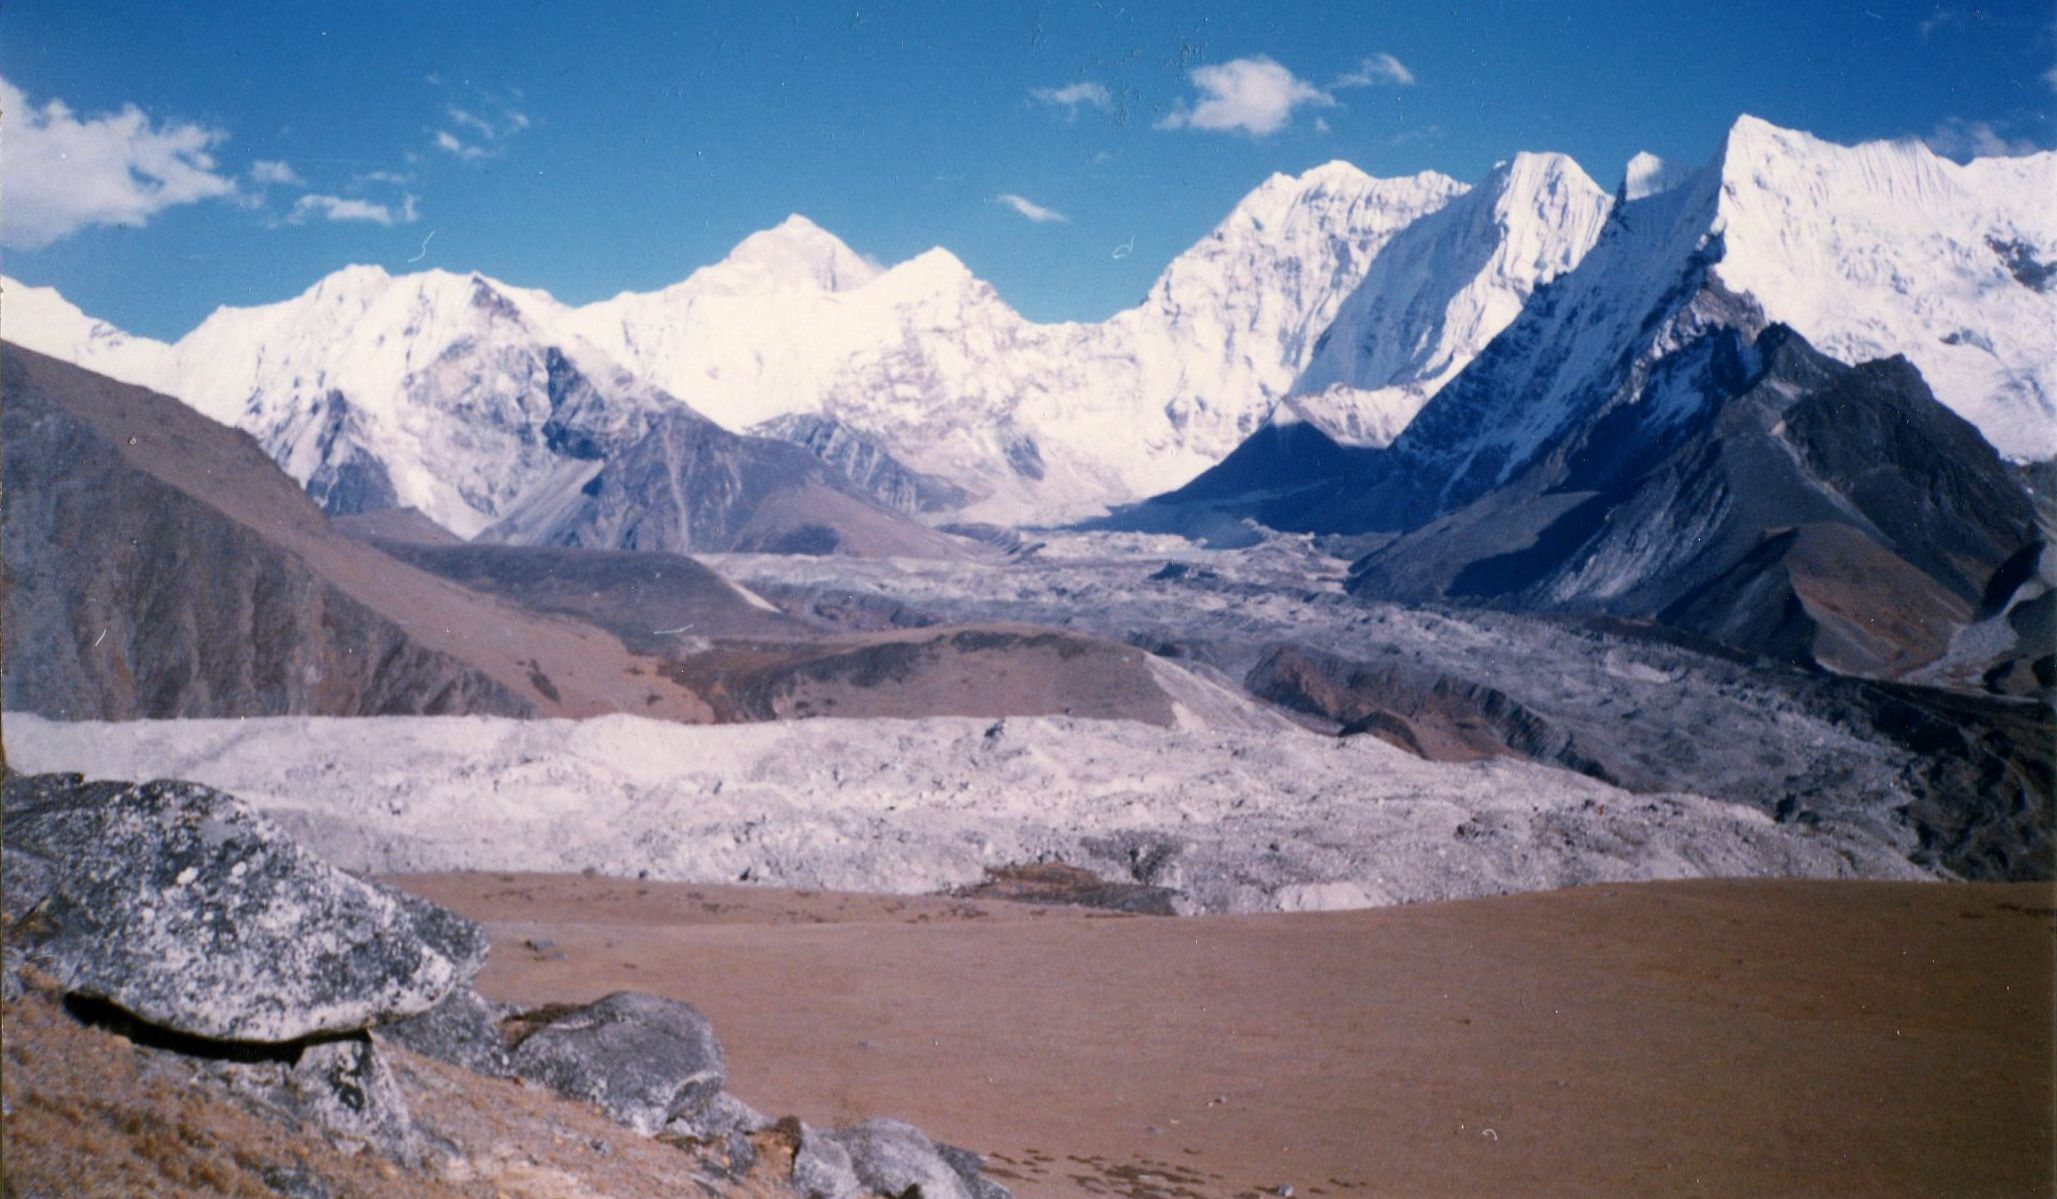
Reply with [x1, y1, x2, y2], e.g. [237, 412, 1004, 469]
[0, 775, 485, 1043]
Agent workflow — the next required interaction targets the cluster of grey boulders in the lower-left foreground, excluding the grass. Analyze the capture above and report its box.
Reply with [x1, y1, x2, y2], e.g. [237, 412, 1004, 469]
[0, 775, 1006, 1199]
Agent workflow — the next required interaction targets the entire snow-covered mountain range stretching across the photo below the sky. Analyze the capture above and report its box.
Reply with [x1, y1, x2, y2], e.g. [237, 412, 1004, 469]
[12, 117, 2057, 537]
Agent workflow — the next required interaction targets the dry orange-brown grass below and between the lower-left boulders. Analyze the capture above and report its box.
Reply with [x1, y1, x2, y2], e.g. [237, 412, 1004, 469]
[0, 970, 790, 1199]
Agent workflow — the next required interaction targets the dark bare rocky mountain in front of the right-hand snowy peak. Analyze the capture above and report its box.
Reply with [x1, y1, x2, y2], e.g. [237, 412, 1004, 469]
[1351, 325, 2036, 677]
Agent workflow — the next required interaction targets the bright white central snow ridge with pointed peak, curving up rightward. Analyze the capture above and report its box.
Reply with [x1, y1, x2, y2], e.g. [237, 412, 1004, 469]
[568, 162, 1463, 518]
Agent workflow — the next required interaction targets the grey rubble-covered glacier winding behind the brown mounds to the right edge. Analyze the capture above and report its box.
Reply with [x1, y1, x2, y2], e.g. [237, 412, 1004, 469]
[706, 529, 2057, 880]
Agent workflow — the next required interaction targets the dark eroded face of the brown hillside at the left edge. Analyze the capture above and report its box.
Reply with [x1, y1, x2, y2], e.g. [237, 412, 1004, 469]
[0, 346, 533, 720]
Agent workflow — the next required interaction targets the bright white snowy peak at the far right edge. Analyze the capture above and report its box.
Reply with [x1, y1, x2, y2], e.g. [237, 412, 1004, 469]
[1709, 117, 2057, 459]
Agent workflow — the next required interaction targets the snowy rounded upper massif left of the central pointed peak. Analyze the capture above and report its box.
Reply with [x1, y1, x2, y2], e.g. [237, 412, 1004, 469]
[175, 267, 671, 537]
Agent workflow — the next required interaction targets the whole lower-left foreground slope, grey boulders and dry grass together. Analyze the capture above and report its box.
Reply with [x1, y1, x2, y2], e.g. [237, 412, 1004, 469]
[0, 775, 1006, 1199]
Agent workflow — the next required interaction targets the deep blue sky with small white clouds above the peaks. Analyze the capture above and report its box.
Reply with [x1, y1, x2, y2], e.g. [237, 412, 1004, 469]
[0, 0, 2057, 337]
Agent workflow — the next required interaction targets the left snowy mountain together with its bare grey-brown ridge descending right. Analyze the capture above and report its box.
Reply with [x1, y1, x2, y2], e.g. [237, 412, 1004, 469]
[8, 267, 959, 555]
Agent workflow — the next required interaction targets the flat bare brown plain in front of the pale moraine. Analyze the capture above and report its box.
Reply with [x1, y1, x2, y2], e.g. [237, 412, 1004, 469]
[397, 874, 2057, 1199]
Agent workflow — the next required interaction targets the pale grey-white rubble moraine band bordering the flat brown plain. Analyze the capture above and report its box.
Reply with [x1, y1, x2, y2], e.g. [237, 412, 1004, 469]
[6, 716, 1927, 913]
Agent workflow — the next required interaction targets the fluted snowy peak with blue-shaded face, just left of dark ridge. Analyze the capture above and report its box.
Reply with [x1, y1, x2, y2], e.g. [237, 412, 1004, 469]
[1282, 154, 1611, 444]
